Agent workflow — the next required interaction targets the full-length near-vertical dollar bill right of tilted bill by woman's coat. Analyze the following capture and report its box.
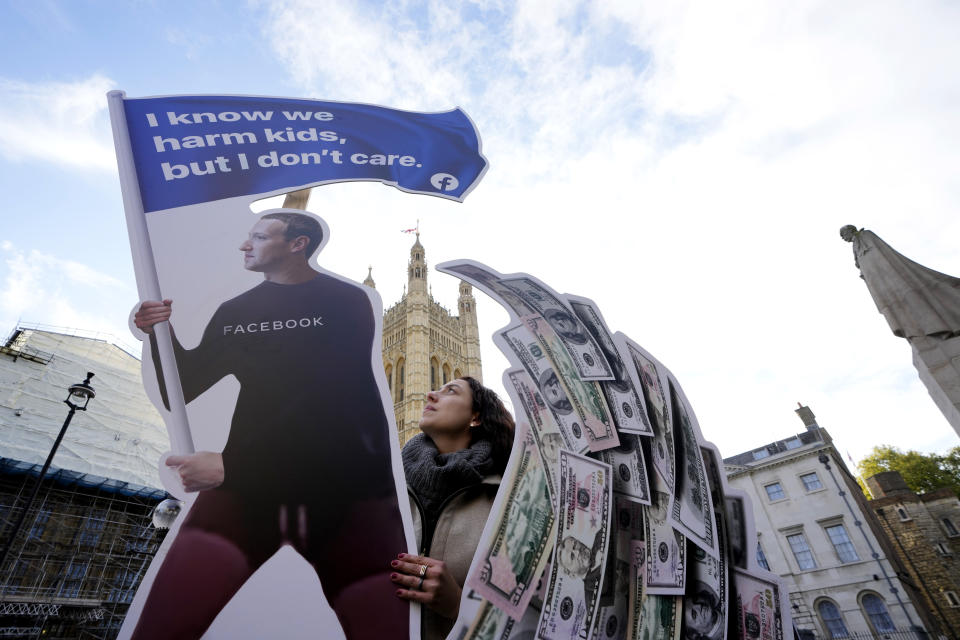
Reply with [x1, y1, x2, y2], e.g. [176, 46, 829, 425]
[537, 451, 613, 640]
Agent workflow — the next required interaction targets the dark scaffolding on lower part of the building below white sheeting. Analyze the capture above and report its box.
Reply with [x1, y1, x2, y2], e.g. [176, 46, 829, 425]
[0, 458, 168, 640]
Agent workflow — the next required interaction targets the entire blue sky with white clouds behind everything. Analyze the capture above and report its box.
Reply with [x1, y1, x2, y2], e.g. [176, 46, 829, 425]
[0, 0, 960, 458]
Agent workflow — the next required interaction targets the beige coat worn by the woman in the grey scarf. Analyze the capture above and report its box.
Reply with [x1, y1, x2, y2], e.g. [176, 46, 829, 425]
[410, 475, 500, 640]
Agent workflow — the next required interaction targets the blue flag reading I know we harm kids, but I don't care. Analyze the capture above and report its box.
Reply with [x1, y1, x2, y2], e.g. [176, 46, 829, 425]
[123, 96, 487, 212]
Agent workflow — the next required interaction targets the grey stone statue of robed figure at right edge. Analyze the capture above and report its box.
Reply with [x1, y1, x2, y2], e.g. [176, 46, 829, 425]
[840, 224, 960, 435]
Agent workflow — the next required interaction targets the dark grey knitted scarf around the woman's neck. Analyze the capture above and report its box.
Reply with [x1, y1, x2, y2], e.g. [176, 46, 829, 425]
[402, 433, 494, 522]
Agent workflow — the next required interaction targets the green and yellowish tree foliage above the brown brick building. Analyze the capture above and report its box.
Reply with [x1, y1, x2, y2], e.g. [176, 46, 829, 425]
[857, 444, 960, 496]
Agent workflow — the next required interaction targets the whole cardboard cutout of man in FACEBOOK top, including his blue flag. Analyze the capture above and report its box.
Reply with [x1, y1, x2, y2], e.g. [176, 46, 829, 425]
[109, 92, 486, 640]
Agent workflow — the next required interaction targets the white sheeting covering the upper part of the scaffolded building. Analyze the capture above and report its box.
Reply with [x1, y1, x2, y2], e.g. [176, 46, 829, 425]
[0, 326, 170, 488]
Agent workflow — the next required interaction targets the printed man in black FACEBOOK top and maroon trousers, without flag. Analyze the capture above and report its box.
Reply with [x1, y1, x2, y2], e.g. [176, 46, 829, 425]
[132, 210, 408, 638]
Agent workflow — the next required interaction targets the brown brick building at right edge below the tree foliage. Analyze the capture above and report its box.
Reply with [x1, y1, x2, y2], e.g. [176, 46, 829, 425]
[866, 471, 960, 640]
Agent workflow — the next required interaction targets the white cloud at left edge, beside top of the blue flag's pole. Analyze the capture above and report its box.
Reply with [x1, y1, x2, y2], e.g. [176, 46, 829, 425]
[0, 74, 116, 171]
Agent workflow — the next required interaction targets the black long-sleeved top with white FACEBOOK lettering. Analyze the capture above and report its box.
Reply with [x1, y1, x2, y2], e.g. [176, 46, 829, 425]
[152, 274, 393, 506]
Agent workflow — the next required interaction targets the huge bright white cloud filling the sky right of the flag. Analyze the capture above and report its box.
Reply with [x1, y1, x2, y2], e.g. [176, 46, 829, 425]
[253, 0, 960, 457]
